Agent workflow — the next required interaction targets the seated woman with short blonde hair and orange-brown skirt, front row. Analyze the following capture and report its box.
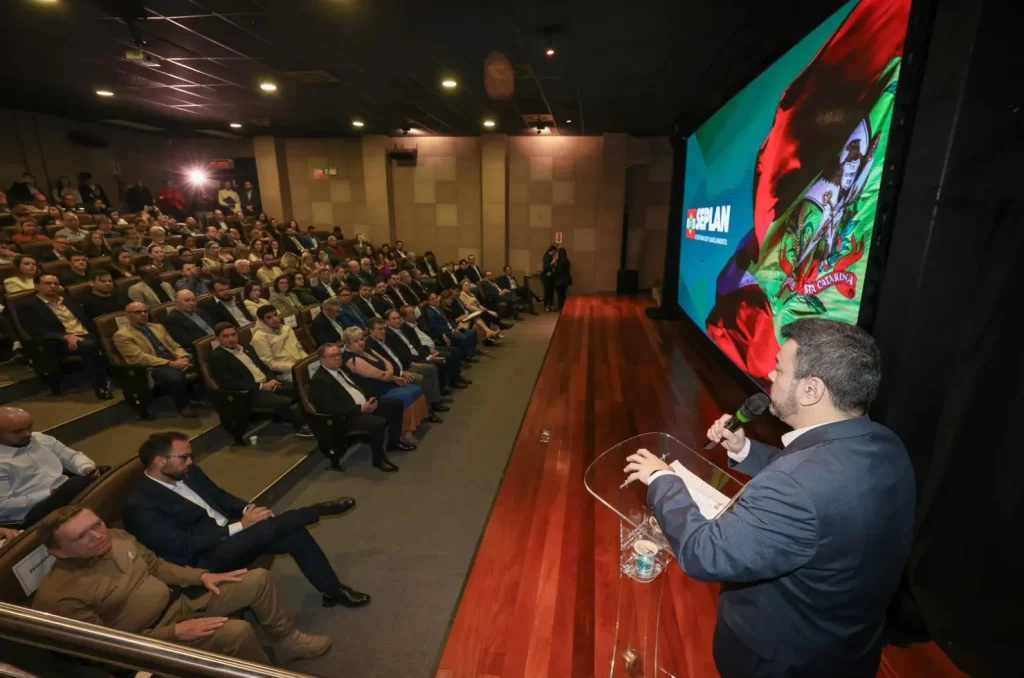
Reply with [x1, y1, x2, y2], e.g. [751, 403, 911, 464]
[341, 328, 429, 444]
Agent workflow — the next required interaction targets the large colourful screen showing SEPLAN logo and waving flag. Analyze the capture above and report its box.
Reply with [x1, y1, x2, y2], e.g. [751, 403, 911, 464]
[679, 0, 910, 382]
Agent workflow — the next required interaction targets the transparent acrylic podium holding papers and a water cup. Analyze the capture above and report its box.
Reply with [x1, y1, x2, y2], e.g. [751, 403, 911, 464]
[584, 433, 743, 678]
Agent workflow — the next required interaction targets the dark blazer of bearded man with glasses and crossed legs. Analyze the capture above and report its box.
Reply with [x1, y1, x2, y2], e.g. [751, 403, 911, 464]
[122, 466, 248, 565]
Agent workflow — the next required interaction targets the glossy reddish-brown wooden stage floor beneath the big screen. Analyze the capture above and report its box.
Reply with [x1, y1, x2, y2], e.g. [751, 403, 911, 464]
[436, 296, 964, 678]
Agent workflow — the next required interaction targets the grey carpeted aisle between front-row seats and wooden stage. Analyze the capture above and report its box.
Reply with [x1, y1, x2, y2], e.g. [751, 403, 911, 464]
[272, 314, 557, 678]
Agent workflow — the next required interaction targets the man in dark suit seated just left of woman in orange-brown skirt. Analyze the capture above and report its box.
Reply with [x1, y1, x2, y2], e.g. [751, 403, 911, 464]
[309, 344, 416, 473]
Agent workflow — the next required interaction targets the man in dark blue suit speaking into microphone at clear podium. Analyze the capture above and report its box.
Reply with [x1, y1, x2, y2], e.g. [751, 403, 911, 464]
[626, 319, 914, 678]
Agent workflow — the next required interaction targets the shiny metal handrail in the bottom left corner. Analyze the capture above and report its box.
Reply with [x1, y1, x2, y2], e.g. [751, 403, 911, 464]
[0, 602, 313, 678]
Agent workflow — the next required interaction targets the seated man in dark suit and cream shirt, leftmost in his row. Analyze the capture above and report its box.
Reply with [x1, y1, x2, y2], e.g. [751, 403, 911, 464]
[17, 273, 114, 400]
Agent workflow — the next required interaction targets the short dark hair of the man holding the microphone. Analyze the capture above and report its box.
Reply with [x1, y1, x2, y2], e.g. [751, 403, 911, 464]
[782, 317, 882, 415]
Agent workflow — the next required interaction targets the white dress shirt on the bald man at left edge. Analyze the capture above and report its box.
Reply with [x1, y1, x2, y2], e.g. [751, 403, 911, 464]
[0, 432, 96, 522]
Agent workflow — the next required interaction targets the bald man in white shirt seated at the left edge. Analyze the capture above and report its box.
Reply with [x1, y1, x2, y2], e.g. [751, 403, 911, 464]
[0, 407, 98, 527]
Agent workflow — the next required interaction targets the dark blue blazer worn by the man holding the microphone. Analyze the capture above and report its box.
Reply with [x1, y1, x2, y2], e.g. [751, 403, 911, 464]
[647, 417, 914, 660]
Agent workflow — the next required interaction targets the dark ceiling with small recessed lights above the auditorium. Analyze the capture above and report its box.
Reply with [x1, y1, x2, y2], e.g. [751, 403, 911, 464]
[0, 0, 841, 136]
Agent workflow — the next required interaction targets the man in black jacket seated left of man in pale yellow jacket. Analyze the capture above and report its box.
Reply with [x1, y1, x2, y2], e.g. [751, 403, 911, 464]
[202, 323, 312, 437]
